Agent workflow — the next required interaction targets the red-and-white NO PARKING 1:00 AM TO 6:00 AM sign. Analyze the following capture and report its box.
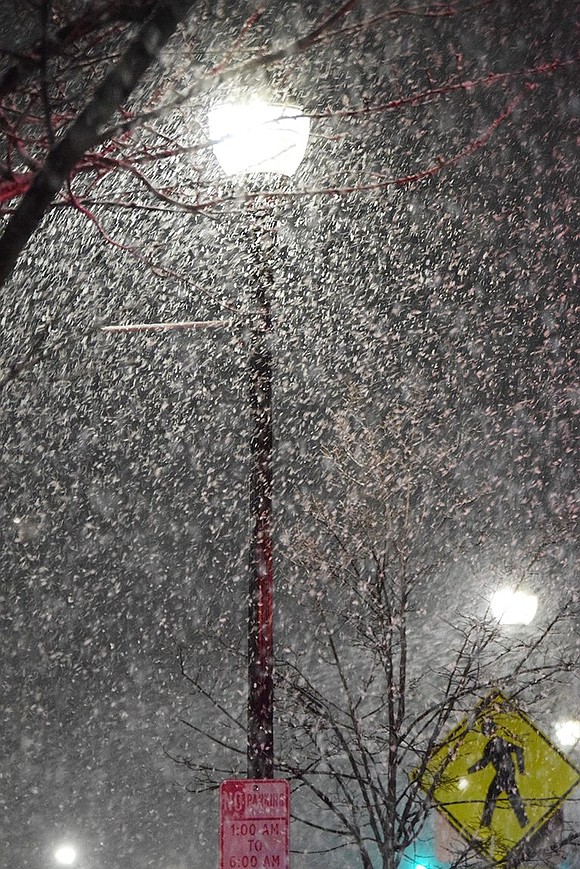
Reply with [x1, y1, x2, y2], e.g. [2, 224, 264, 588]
[220, 779, 290, 869]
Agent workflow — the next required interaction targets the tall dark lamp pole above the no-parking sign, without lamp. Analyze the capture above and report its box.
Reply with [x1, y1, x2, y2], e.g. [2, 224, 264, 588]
[247, 216, 276, 779]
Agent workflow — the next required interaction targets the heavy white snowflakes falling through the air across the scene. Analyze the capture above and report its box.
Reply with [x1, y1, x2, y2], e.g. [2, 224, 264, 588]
[0, 0, 580, 869]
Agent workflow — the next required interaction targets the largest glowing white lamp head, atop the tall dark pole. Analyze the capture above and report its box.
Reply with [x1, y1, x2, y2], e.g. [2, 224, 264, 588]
[208, 100, 310, 175]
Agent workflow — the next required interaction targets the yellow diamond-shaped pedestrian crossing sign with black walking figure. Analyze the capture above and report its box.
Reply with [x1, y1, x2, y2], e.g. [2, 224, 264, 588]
[415, 692, 580, 863]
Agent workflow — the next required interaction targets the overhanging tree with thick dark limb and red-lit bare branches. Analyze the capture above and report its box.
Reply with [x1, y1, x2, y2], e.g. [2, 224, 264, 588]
[0, 0, 575, 283]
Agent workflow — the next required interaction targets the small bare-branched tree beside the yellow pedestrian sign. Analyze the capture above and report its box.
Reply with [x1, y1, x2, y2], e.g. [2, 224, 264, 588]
[175, 397, 579, 869]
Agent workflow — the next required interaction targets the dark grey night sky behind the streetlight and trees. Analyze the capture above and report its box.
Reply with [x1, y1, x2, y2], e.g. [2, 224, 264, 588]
[0, 0, 580, 869]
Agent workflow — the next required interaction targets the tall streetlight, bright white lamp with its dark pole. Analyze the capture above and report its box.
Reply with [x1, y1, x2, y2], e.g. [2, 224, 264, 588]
[208, 100, 310, 779]
